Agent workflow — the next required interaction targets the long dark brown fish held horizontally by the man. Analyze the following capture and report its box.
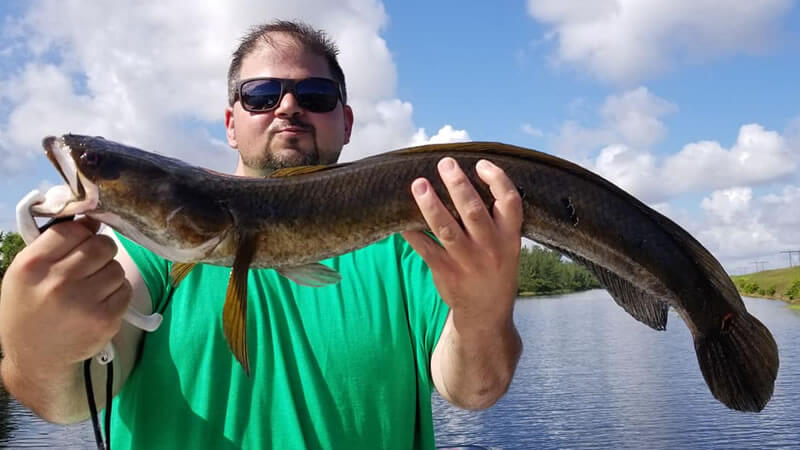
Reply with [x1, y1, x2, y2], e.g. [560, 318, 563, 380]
[36, 135, 779, 411]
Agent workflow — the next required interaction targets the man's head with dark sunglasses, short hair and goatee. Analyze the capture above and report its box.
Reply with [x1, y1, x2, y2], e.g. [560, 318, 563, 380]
[225, 21, 353, 176]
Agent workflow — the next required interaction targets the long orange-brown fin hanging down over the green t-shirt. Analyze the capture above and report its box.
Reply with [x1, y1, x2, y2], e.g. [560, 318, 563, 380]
[222, 234, 255, 377]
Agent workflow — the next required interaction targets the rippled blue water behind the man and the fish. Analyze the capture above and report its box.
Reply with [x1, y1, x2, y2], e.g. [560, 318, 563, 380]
[0, 290, 800, 449]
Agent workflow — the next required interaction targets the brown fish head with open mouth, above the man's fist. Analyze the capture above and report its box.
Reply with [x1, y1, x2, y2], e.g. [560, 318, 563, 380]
[42, 134, 232, 262]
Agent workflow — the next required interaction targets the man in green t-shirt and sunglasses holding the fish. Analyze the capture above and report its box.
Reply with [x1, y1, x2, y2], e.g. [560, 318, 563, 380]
[0, 22, 522, 449]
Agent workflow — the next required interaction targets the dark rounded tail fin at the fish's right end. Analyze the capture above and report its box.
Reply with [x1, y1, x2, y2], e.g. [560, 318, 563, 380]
[694, 311, 779, 412]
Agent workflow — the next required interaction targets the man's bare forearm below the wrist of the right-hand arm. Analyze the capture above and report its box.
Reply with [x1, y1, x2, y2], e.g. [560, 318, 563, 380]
[432, 311, 522, 409]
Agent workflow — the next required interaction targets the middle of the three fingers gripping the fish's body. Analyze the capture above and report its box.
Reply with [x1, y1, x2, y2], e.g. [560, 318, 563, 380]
[438, 158, 495, 242]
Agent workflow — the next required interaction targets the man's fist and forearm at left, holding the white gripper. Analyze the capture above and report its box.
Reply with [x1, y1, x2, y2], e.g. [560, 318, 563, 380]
[0, 219, 152, 423]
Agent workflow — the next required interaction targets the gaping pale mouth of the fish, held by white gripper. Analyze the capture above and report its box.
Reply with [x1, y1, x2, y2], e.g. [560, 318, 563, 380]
[31, 136, 99, 217]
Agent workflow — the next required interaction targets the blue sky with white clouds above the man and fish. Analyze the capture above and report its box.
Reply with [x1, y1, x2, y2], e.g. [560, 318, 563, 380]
[0, 0, 800, 274]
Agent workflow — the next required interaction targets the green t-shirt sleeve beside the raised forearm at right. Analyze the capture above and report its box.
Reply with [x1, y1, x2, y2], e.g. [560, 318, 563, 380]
[397, 237, 450, 386]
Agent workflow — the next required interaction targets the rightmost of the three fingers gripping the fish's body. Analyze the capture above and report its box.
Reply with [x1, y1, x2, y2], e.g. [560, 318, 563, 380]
[476, 159, 522, 234]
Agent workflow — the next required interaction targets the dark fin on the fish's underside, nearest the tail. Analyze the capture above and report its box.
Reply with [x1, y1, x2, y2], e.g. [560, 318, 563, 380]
[559, 249, 669, 330]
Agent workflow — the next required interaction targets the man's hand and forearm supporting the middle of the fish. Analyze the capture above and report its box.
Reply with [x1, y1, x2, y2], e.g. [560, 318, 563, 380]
[403, 158, 522, 409]
